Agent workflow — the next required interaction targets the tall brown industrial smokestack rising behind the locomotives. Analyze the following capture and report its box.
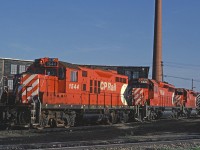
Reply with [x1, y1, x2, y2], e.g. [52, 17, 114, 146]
[152, 0, 163, 81]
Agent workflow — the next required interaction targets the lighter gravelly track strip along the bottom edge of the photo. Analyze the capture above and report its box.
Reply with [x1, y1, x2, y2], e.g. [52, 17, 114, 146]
[0, 135, 200, 150]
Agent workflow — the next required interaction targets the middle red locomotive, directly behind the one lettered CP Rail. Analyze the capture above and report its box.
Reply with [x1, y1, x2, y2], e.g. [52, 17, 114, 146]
[132, 78, 175, 119]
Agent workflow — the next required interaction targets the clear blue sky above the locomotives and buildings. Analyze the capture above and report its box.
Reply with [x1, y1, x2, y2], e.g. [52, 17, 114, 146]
[0, 0, 200, 90]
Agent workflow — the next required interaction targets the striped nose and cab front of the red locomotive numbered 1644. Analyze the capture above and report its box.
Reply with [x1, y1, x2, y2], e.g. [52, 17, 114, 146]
[14, 57, 59, 104]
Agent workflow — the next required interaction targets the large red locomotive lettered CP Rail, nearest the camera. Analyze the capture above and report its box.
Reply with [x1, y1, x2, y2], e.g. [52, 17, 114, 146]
[11, 58, 130, 126]
